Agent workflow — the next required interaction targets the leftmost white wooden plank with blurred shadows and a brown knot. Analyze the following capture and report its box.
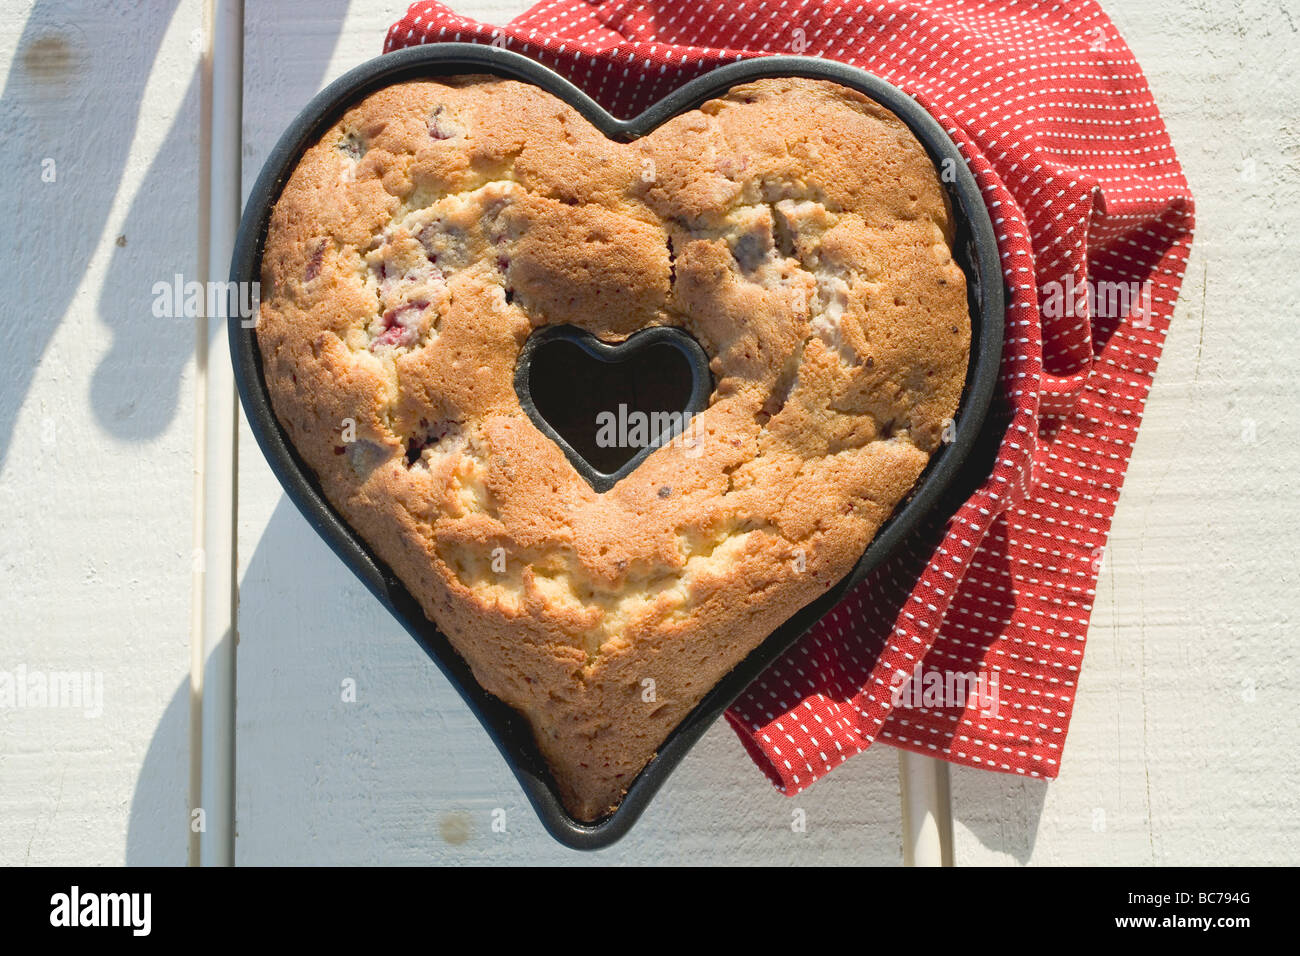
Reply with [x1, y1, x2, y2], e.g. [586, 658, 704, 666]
[0, 0, 203, 865]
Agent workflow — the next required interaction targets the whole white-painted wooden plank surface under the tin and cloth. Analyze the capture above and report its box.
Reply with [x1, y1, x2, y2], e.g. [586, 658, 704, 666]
[0, 0, 1300, 864]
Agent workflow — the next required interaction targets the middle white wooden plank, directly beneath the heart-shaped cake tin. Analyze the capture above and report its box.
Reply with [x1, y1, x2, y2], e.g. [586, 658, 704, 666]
[237, 3, 901, 864]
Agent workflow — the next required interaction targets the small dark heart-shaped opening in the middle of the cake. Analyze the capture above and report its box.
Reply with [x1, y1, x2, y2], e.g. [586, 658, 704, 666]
[515, 325, 712, 492]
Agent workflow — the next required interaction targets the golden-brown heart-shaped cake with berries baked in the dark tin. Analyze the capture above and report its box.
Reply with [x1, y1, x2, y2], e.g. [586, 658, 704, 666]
[256, 77, 971, 821]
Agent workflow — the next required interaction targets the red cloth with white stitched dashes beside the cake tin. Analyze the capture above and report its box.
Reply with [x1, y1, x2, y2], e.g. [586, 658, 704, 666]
[385, 0, 1192, 793]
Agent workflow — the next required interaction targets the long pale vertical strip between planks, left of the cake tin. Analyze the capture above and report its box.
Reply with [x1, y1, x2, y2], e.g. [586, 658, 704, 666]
[196, 0, 243, 866]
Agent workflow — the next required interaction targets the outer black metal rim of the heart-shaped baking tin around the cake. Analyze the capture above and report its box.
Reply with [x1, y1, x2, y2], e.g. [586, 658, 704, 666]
[229, 43, 1004, 849]
